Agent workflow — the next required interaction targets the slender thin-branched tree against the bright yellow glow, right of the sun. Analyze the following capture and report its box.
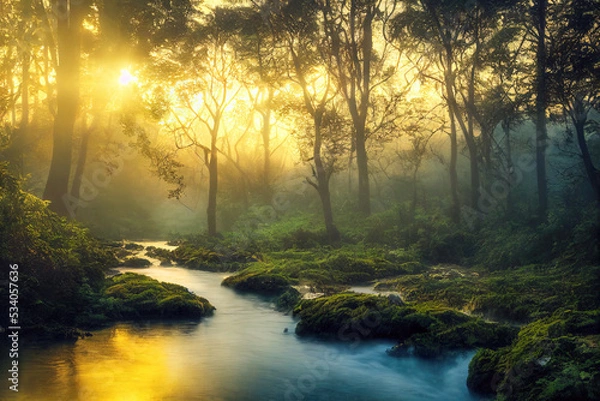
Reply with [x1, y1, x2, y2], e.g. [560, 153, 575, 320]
[159, 8, 241, 236]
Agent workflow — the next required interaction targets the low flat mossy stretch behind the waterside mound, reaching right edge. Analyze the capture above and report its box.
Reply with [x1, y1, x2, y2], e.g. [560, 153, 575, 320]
[376, 265, 600, 323]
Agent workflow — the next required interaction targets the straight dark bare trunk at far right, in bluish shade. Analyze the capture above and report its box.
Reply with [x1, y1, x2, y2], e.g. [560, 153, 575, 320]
[535, 0, 548, 221]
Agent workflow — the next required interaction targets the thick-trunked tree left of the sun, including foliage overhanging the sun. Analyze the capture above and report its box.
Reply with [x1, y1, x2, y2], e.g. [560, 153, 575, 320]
[44, 0, 193, 215]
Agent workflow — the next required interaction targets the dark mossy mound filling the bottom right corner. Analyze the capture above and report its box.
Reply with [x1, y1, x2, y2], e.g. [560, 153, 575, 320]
[467, 310, 600, 401]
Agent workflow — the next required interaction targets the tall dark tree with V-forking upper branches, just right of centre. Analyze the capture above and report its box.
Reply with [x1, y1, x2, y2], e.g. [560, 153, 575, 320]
[320, 0, 395, 215]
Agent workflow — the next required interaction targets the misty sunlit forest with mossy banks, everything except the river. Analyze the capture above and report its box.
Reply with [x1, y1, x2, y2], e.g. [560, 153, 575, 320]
[0, 0, 600, 401]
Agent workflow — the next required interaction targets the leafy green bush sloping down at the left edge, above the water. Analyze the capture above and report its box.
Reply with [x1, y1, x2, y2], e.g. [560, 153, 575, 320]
[0, 165, 117, 331]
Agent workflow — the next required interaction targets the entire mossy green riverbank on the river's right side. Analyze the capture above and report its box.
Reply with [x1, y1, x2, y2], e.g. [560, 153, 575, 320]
[162, 234, 600, 400]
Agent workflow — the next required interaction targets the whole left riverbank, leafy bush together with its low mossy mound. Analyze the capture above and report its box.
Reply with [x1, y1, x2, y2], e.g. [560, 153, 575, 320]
[0, 165, 214, 338]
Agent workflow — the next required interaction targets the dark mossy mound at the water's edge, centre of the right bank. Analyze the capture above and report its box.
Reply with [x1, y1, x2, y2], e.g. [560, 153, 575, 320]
[294, 293, 516, 357]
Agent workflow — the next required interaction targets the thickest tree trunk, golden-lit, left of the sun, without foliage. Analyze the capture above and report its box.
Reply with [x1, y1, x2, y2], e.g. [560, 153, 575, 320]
[44, 0, 83, 216]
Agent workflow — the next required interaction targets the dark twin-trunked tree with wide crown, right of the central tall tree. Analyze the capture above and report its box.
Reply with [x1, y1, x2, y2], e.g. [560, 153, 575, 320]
[394, 0, 516, 221]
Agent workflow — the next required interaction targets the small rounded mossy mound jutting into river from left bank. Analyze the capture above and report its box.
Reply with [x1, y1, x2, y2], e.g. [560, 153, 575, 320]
[103, 273, 215, 319]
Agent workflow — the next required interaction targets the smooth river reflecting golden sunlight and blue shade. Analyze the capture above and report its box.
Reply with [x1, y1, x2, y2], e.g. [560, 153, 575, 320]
[2, 243, 477, 401]
